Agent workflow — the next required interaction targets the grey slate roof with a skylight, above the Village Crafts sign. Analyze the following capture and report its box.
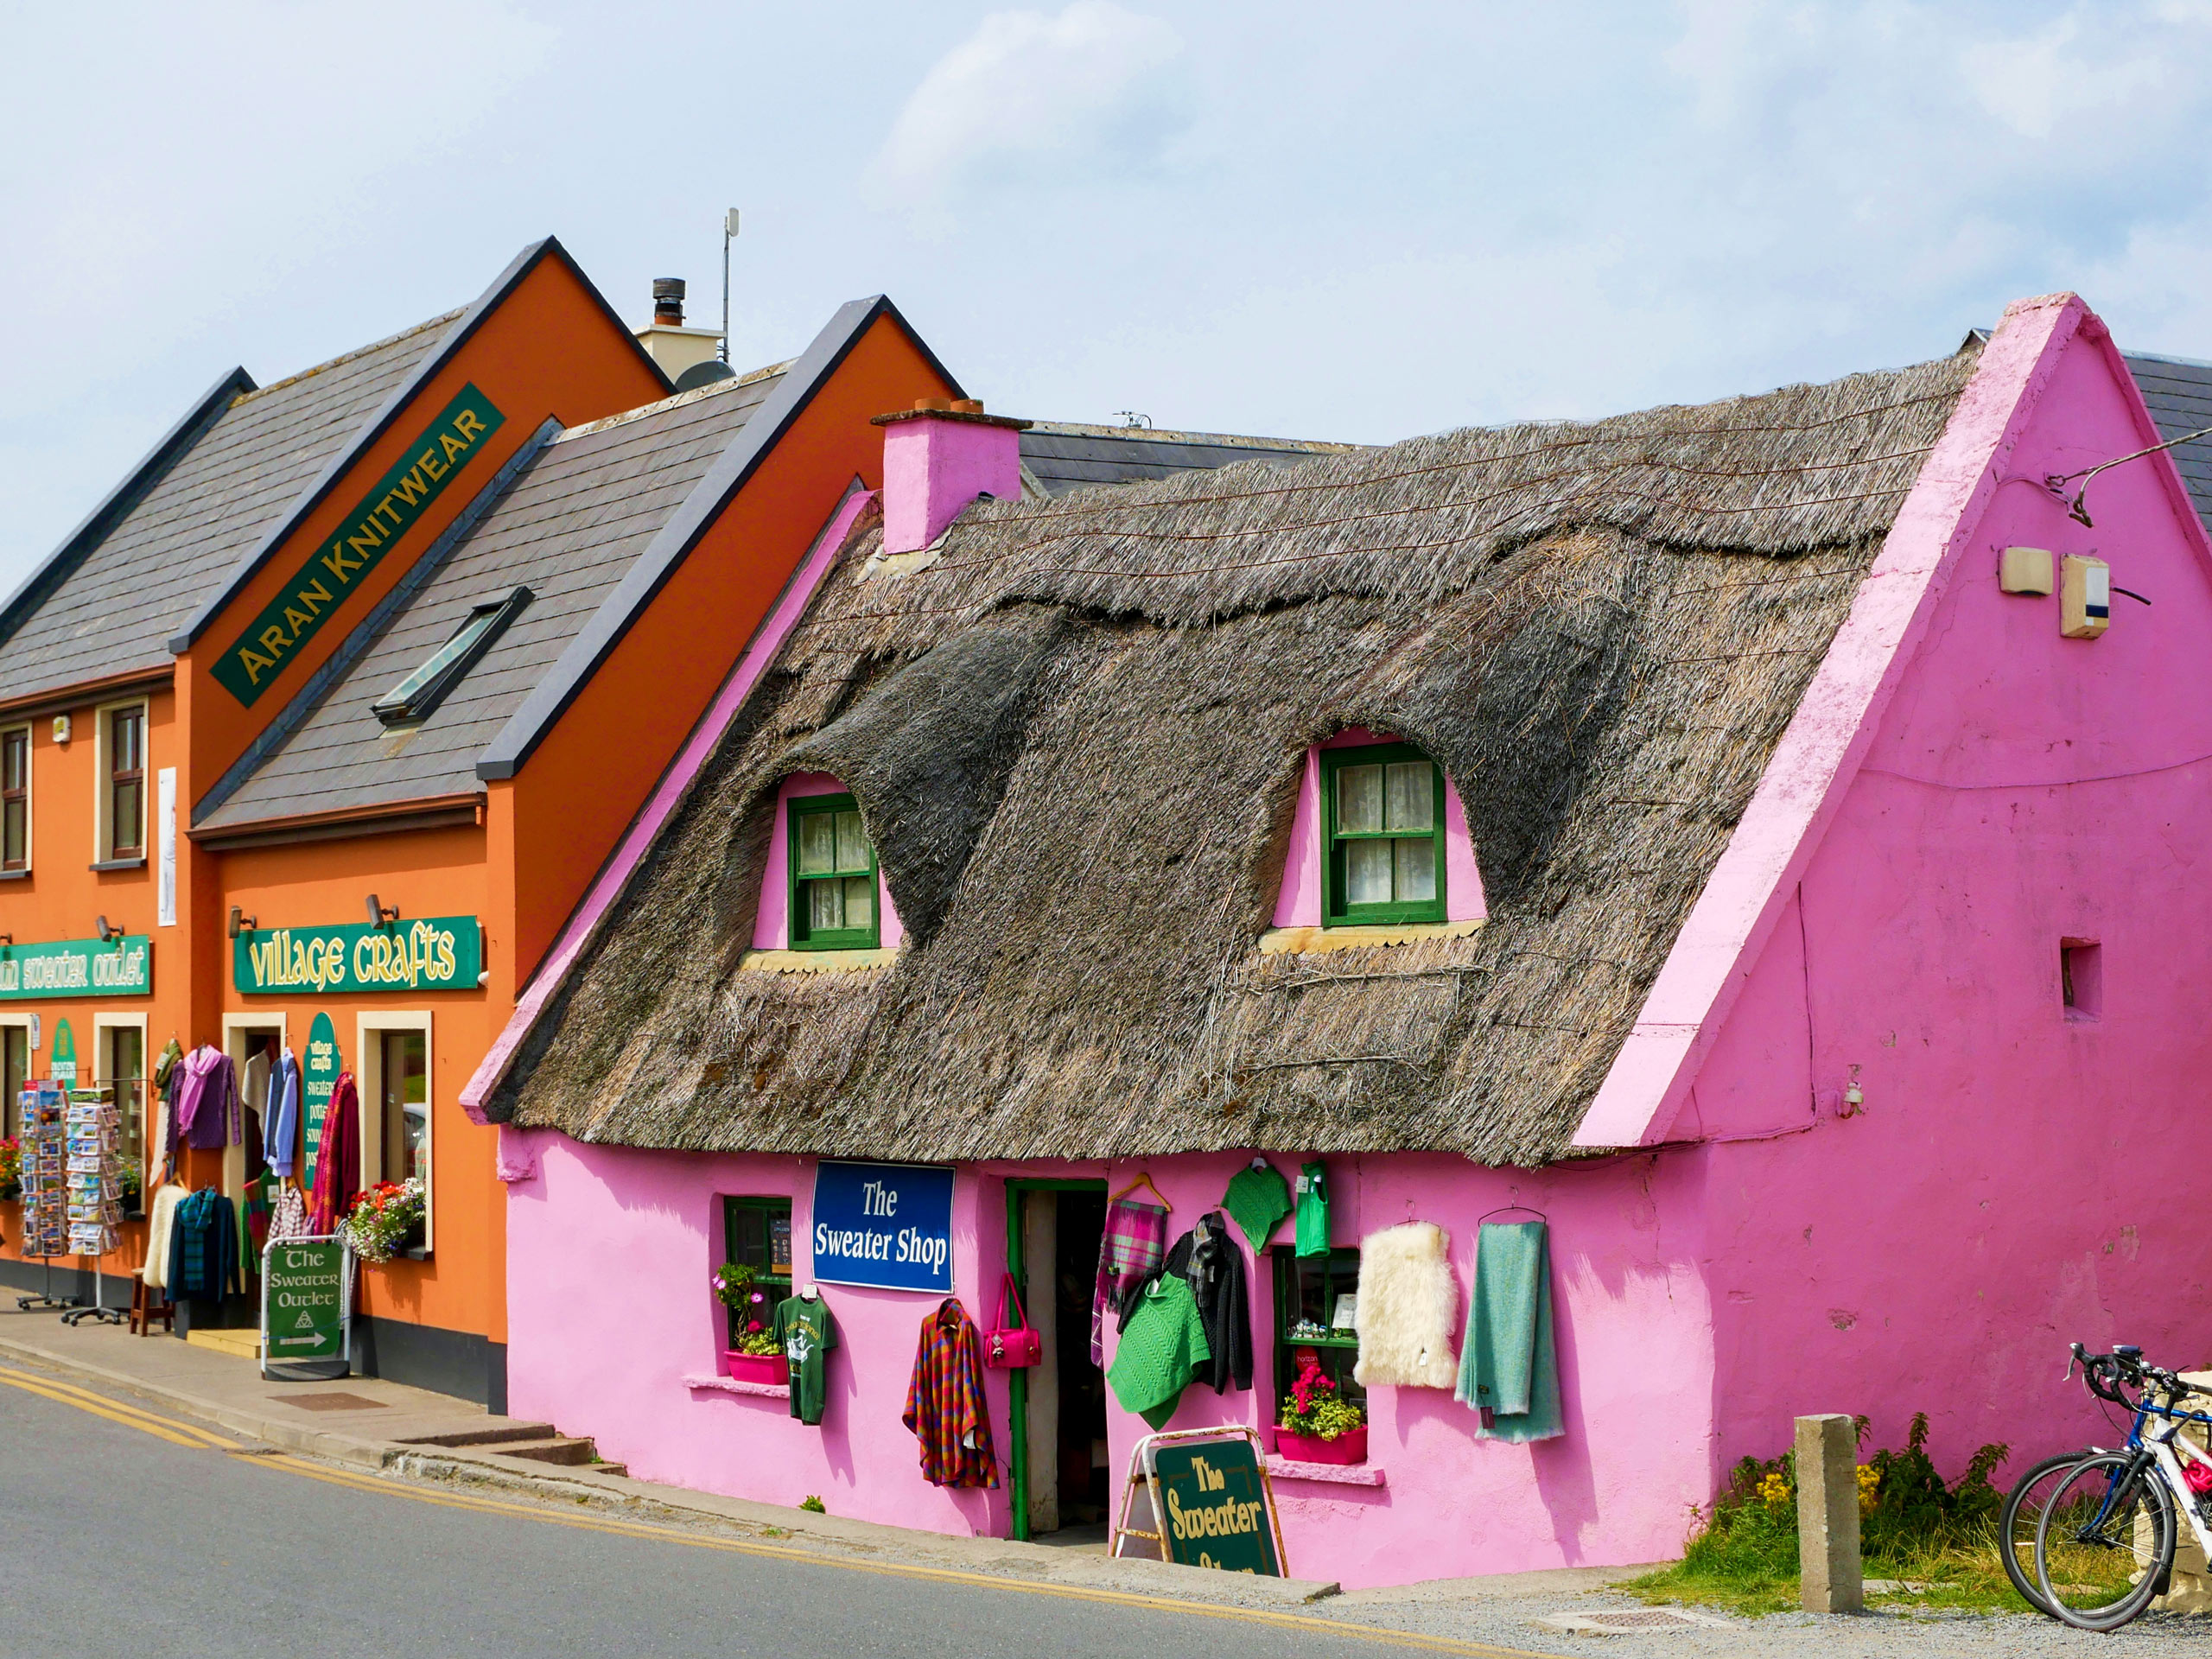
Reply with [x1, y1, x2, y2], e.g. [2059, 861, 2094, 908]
[193, 365, 783, 830]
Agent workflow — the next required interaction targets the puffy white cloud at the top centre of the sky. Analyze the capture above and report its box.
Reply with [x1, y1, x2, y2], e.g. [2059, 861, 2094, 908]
[868, 0, 1190, 221]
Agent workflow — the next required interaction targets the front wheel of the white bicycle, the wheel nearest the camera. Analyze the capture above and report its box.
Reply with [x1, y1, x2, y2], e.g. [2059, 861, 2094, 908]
[2035, 1451, 2174, 1630]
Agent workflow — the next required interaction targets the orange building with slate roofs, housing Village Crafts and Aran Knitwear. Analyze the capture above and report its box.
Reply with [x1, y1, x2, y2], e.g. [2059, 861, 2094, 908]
[0, 238, 1344, 1409]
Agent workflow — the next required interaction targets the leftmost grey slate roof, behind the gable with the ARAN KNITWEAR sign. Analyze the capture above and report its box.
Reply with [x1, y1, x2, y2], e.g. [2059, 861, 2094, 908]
[0, 312, 460, 699]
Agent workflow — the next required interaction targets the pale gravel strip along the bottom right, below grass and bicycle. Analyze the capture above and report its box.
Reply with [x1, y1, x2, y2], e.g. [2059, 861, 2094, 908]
[1314, 1595, 2212, 1659]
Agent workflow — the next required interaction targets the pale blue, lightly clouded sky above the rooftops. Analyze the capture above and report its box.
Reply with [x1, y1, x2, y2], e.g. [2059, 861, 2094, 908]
[0, 0, 2212, 588]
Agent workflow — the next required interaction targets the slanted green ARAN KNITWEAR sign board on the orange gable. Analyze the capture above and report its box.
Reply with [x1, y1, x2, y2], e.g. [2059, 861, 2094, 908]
[214, 385, 506, 708]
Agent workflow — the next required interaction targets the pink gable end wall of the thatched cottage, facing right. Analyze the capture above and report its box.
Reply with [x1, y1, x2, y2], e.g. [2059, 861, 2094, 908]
[1675, 302, 2212, 1471]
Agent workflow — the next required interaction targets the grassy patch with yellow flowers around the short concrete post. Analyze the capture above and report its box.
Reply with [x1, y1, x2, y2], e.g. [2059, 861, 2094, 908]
[1619, 1414, 2033, 1615]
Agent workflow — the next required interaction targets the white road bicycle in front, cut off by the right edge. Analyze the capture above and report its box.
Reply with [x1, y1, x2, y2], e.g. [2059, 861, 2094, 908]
[2035, 1343, 2212, 1630]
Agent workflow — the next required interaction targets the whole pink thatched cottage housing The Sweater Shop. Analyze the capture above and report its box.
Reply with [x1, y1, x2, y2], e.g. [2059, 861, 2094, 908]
[469, 294, 2212, 1586]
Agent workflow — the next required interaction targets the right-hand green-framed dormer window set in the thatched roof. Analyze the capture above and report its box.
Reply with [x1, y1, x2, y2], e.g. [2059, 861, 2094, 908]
[1320, 743, 1445, 927]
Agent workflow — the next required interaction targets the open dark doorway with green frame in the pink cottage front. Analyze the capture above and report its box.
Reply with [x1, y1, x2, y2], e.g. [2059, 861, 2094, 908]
[991, 1181, 1110, 1544]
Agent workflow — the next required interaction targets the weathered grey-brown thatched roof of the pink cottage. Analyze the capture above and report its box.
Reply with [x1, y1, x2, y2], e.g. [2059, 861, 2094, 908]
[486, 349, 1975, 1164]
